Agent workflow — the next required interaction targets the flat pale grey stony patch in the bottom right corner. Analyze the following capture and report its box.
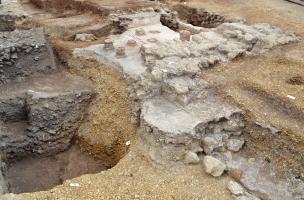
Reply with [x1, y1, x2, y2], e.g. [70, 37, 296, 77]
[225, 156, 304, 200]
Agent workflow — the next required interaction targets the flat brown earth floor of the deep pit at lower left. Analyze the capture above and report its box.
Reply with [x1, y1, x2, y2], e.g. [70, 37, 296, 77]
[4, 144, 108, 194]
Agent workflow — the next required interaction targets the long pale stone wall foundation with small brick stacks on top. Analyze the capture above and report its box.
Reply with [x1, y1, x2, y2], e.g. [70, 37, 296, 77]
[73, 12, 299, 199]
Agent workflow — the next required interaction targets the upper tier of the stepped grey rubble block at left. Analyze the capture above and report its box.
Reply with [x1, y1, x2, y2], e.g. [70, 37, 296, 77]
[0, 28, 56, 83]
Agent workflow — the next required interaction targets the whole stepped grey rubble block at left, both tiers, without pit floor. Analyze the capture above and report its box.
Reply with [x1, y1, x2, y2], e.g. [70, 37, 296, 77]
[0, 28, 95, 159]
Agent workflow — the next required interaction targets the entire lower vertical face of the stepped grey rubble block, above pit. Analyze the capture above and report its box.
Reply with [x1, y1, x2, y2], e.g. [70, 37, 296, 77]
[0, 81, 94, 158]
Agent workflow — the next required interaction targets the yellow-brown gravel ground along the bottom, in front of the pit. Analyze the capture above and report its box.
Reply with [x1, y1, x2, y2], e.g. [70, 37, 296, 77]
[1, 144, 232, 200]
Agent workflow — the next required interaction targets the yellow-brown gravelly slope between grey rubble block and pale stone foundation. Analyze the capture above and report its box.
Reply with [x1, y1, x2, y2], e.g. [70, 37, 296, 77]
[69, 59, 135, 166]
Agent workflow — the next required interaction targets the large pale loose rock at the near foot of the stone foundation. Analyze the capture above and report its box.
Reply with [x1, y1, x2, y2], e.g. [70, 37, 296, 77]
[203, 156, 226, 177]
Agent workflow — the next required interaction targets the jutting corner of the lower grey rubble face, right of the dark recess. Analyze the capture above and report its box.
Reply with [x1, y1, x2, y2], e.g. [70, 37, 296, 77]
[26, 90, 94, 155]
